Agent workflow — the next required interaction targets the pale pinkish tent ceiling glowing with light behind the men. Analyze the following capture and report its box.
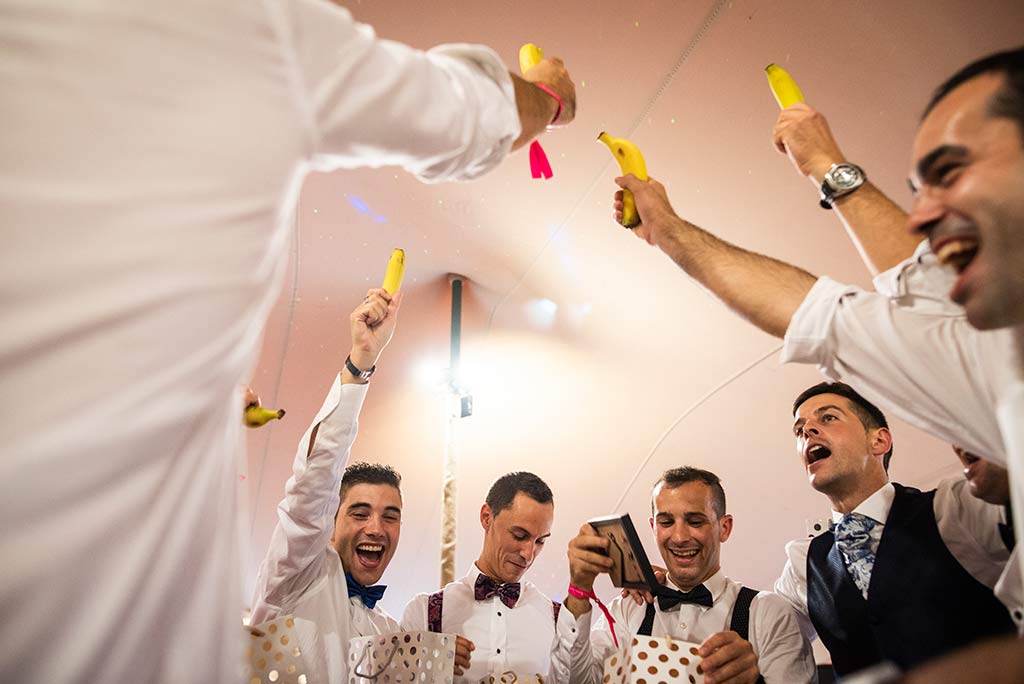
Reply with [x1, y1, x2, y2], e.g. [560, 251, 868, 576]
[243, 0, 1024, 614]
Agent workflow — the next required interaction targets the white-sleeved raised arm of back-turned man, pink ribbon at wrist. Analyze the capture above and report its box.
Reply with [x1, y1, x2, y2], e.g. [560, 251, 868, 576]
[290, 2, 575, 182]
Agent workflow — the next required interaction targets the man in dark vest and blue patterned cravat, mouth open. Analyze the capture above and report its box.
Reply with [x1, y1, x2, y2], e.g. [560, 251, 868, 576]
[775, 383, 1013, 676]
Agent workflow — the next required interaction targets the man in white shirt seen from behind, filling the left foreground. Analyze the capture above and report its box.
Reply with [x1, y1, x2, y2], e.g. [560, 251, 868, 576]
[0, 0, 574, 684]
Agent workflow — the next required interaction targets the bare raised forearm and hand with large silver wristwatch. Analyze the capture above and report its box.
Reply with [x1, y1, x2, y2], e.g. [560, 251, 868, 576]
[772, 102, 921, 275]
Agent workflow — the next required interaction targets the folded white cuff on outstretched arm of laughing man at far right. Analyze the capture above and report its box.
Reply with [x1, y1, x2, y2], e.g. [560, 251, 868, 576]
[780, 276, 858, 365]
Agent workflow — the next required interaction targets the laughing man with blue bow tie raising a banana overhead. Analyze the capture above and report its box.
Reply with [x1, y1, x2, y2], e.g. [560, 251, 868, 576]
[251, 290, 401, 682]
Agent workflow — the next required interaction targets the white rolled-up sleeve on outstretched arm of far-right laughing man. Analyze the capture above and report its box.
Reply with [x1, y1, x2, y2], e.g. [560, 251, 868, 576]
[781, 277, 1013, 463]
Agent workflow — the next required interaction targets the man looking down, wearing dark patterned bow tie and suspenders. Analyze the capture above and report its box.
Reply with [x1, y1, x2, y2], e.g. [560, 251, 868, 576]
[401, 472, 577, 684]
